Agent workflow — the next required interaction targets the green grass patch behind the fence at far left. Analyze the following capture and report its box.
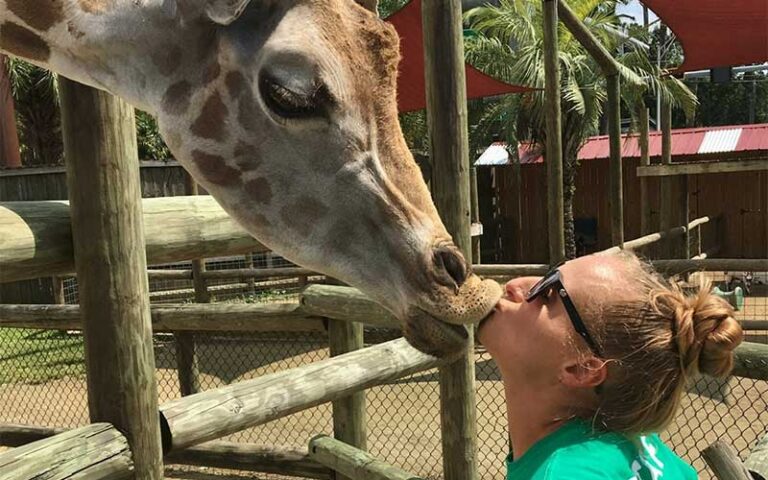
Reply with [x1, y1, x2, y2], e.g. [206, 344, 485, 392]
[0, 328, 85, 385]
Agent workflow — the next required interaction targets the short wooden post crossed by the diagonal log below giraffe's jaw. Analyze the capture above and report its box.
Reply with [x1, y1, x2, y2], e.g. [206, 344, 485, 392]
[328, 319, 368, 480]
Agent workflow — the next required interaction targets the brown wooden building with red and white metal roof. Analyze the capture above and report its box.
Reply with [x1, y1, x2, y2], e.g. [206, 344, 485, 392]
[475, 124, 768, 263]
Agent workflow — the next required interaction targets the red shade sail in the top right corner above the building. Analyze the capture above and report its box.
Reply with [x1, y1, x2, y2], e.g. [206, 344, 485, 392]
[643, 0, 768, 72]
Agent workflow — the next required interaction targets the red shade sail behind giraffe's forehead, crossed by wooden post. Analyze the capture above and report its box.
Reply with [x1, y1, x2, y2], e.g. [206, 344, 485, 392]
[387, 0, 530, 112]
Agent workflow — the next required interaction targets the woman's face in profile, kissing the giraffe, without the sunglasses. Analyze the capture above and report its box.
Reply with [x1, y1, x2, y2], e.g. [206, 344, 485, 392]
[478, 256, 616, 385]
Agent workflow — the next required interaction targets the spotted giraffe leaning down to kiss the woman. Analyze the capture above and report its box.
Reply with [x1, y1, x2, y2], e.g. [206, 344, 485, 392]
[0, 0, 501, 356]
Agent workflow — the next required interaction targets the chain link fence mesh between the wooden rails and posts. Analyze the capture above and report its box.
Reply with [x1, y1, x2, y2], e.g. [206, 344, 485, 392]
[0, 264, 768, 480]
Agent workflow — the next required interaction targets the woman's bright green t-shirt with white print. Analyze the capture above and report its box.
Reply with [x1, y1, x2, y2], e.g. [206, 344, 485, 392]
[507, 420, 698, 480]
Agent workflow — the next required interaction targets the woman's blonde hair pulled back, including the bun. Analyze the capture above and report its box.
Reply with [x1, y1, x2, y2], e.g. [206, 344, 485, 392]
[587, 253, 742, 434]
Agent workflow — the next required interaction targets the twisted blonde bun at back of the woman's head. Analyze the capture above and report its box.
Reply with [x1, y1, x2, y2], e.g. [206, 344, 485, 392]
[667, 282, 744, 377]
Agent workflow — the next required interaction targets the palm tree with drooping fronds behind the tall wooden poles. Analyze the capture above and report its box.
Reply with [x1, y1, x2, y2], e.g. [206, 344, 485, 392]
[466, 0, 697, 258]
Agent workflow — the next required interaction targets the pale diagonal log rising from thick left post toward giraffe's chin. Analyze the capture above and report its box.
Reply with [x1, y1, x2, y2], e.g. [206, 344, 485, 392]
[160, 339, 441, 451]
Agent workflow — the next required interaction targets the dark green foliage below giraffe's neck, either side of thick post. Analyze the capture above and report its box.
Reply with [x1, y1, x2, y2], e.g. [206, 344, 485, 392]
[8, 59, 171, 167]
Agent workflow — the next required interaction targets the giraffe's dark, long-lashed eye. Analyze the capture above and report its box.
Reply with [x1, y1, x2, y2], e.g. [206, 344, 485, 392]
[259, 75, 328, 120]
